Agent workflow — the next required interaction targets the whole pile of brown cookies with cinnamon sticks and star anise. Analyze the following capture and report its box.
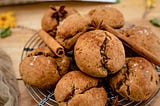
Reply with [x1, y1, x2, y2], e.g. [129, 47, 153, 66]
[20, 6, 160, 106]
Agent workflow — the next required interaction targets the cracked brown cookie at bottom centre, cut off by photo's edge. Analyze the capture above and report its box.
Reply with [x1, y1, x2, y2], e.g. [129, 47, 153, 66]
[54, 70, 107, 106]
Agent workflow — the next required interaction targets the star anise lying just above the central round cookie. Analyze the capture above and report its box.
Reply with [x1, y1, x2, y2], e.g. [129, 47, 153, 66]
[88, 20, 105, 31]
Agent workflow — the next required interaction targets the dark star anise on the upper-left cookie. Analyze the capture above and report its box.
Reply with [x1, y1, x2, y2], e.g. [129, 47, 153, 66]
[50, 6, 67, 22]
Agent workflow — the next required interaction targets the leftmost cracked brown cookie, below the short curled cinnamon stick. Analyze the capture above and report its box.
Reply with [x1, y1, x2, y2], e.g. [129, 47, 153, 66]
[19, 46, 70, 89]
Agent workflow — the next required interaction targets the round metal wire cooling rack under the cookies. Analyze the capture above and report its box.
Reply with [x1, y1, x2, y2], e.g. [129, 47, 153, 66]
[21, 33, 160, 106]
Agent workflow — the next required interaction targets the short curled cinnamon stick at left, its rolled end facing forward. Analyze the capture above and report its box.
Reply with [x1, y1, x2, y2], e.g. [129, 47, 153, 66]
[38, 29, 65, 57]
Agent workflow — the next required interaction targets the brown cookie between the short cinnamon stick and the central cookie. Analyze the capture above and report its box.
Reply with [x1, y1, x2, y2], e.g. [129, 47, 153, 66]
[56, 14, 91, 50]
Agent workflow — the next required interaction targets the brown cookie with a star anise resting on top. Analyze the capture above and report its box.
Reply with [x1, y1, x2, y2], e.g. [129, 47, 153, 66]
[41, 6, 77, 36]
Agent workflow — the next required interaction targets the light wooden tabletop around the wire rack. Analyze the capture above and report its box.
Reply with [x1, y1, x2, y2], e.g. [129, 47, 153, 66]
[0, 0, 160, 106]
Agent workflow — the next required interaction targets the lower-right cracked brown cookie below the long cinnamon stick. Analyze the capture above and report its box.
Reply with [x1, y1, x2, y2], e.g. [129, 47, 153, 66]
[109, 57, 159, 101]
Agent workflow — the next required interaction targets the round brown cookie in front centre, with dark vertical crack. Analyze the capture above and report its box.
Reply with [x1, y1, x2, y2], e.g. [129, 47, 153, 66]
[74, 30, 125, 77]
